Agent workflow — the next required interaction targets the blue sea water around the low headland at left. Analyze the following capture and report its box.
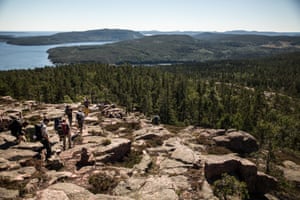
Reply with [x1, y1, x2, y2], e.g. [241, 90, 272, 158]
[0, 32, 112, 71]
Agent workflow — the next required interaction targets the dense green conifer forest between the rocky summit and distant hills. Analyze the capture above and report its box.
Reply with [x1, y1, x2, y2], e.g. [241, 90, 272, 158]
[0, 52, 300, 150]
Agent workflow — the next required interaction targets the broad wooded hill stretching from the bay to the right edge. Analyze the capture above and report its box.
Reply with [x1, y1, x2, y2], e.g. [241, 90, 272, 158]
[48, 33, 300, 64]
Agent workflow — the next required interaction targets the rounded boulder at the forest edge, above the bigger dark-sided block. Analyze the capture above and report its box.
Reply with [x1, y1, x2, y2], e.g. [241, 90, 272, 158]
[213, 131, 258, 153]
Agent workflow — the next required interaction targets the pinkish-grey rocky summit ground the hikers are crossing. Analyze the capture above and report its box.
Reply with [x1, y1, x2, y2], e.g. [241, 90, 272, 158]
[0, 97, 280, 200]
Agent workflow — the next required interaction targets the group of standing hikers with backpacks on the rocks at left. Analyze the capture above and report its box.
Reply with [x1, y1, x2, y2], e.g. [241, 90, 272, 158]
[9, 98, 89, 160]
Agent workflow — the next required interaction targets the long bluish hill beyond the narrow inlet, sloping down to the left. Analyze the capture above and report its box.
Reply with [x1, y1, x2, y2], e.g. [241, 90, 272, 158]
[7, 29, 143, 45]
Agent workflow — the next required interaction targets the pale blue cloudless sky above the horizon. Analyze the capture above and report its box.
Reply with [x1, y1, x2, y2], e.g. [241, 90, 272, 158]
[0, 0, 300, 32]
